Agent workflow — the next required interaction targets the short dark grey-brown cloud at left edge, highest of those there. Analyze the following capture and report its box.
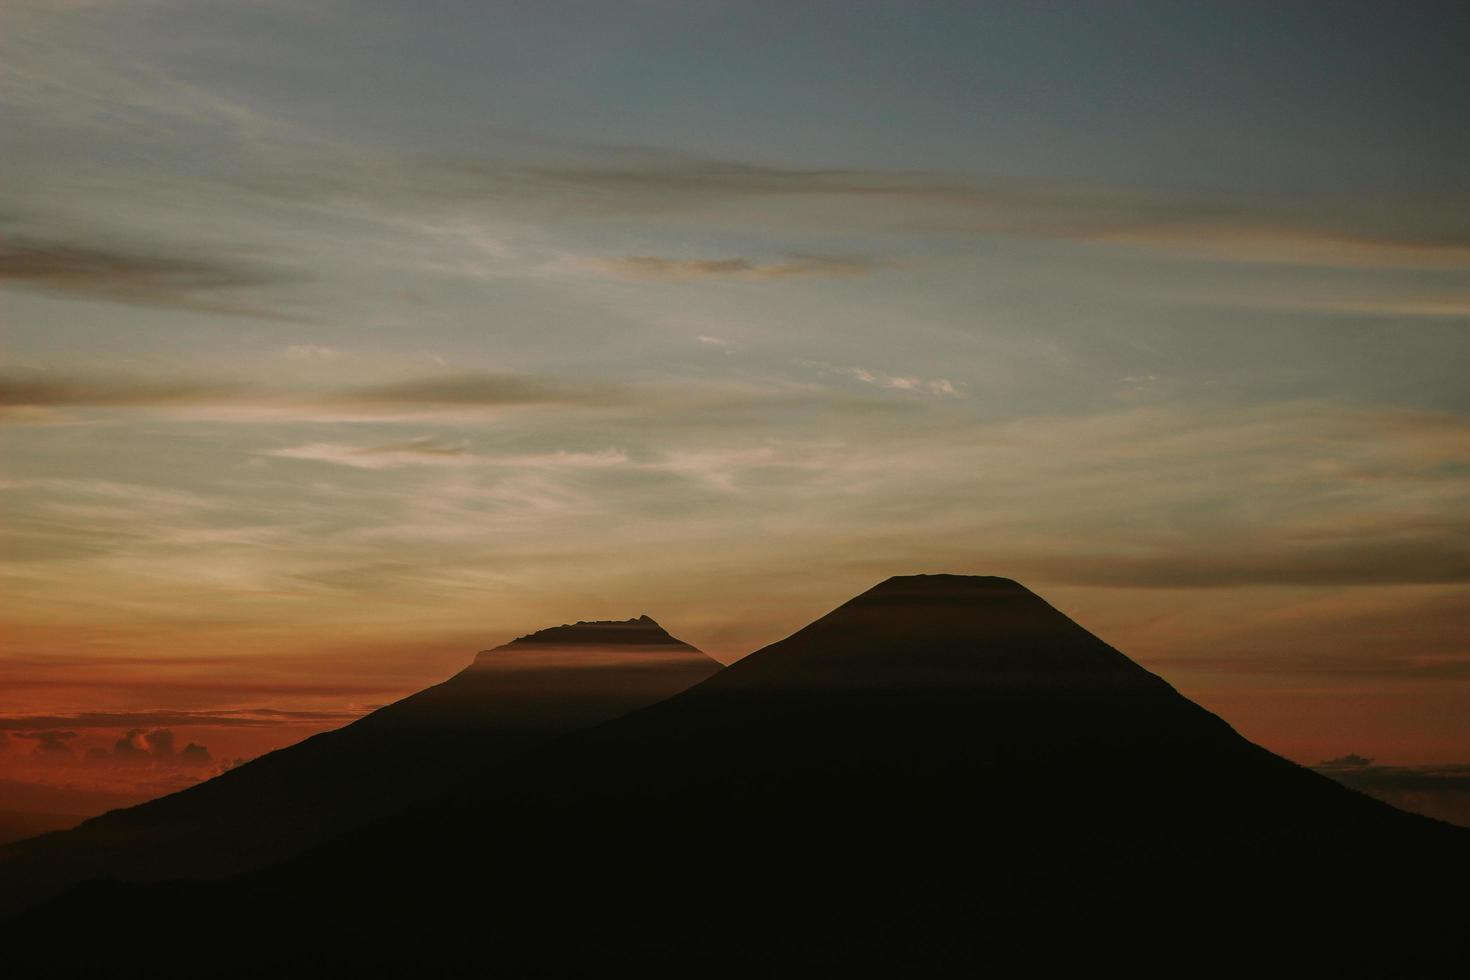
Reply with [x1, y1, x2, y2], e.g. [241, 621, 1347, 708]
[0, 239, 297, 319]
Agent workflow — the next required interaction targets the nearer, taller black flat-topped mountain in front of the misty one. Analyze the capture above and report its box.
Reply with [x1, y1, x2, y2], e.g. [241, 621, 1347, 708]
[0, 576, 1470, 977]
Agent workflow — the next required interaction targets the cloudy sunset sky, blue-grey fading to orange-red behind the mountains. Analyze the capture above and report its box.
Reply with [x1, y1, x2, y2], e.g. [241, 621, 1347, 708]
[0, 0, 1470, 813]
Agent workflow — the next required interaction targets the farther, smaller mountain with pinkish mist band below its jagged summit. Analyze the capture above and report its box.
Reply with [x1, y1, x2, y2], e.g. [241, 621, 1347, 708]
[0, 616, 720, 911]
